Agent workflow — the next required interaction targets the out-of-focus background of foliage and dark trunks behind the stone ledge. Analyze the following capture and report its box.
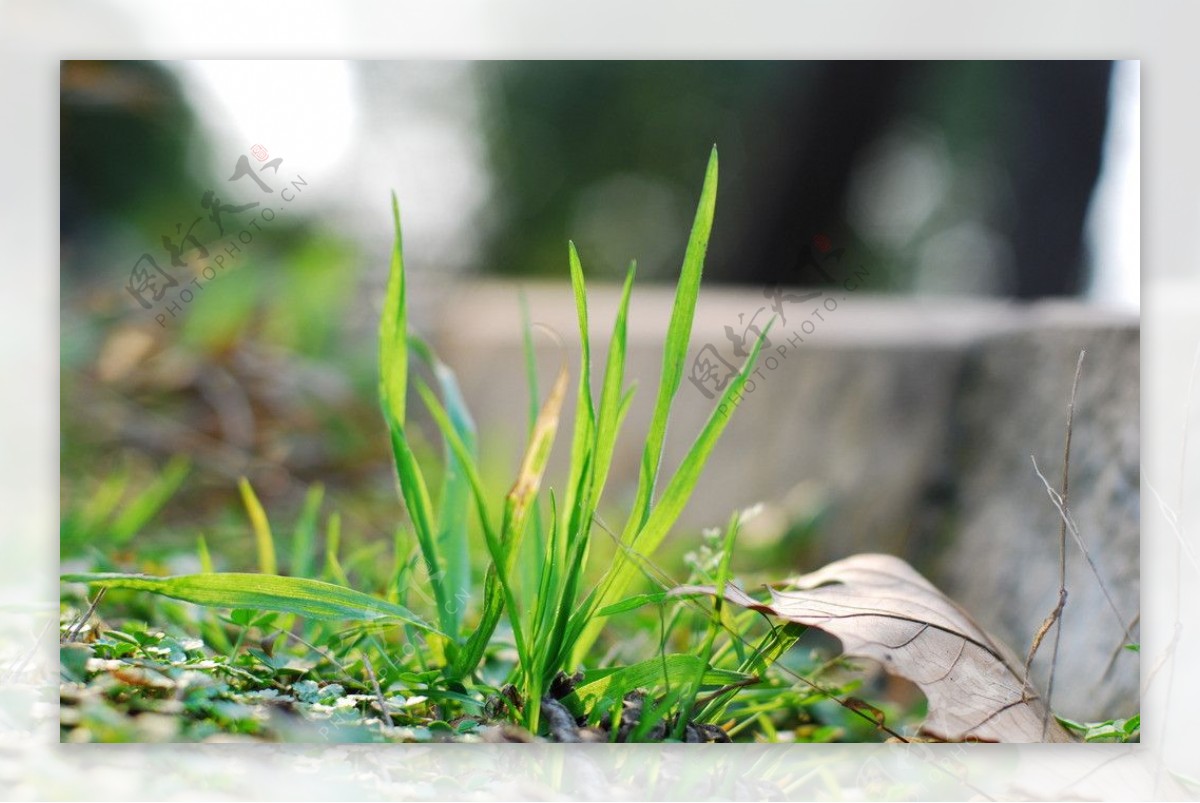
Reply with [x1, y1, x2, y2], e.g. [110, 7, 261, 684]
[60, 61, 1135, 570]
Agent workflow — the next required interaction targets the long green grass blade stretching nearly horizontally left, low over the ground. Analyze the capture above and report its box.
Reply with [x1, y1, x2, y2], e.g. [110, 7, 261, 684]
[60, 573, 437, 633]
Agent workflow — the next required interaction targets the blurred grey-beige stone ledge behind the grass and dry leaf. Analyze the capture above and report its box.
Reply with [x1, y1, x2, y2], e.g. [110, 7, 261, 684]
[429, 282, 1140, 719]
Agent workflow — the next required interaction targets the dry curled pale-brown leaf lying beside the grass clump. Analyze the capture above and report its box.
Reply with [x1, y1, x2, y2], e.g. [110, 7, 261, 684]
[673, 555, 1073, 742]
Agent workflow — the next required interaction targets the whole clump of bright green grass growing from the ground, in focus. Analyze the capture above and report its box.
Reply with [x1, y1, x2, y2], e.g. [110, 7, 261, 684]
[62, 149, 828, 739]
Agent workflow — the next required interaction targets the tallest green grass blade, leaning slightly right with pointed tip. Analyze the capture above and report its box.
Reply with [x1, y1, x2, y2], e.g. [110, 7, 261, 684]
[626, 148, 718, 533]
